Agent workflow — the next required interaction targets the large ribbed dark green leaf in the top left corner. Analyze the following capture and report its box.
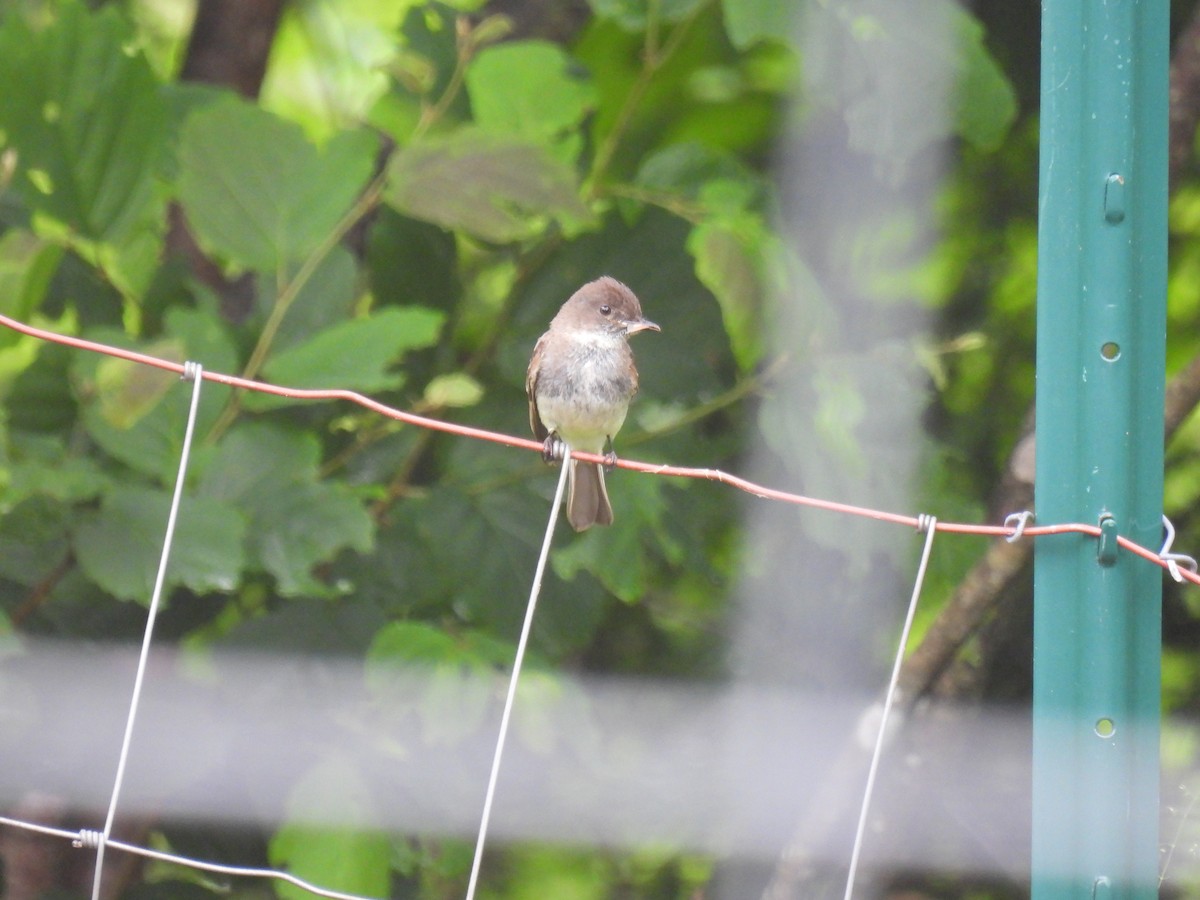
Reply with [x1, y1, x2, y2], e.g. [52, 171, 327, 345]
[0, 2, 167, 252]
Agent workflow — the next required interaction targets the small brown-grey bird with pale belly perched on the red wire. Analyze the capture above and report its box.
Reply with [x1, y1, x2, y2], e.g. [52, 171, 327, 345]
[526, 275, 661, 532]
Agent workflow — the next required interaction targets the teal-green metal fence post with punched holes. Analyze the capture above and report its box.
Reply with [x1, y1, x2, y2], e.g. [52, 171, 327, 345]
[1032, 0, 1170, 900]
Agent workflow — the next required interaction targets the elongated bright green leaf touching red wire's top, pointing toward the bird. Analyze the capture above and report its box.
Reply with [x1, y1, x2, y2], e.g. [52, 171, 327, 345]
[246, 306, 445, 409]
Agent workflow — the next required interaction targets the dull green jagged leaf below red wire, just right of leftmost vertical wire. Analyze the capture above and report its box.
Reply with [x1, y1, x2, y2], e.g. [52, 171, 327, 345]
[197, 422, 374, 596]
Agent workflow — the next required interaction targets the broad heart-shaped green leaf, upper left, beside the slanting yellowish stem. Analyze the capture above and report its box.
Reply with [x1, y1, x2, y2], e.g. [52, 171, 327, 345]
[179, 98, 378, 272]
